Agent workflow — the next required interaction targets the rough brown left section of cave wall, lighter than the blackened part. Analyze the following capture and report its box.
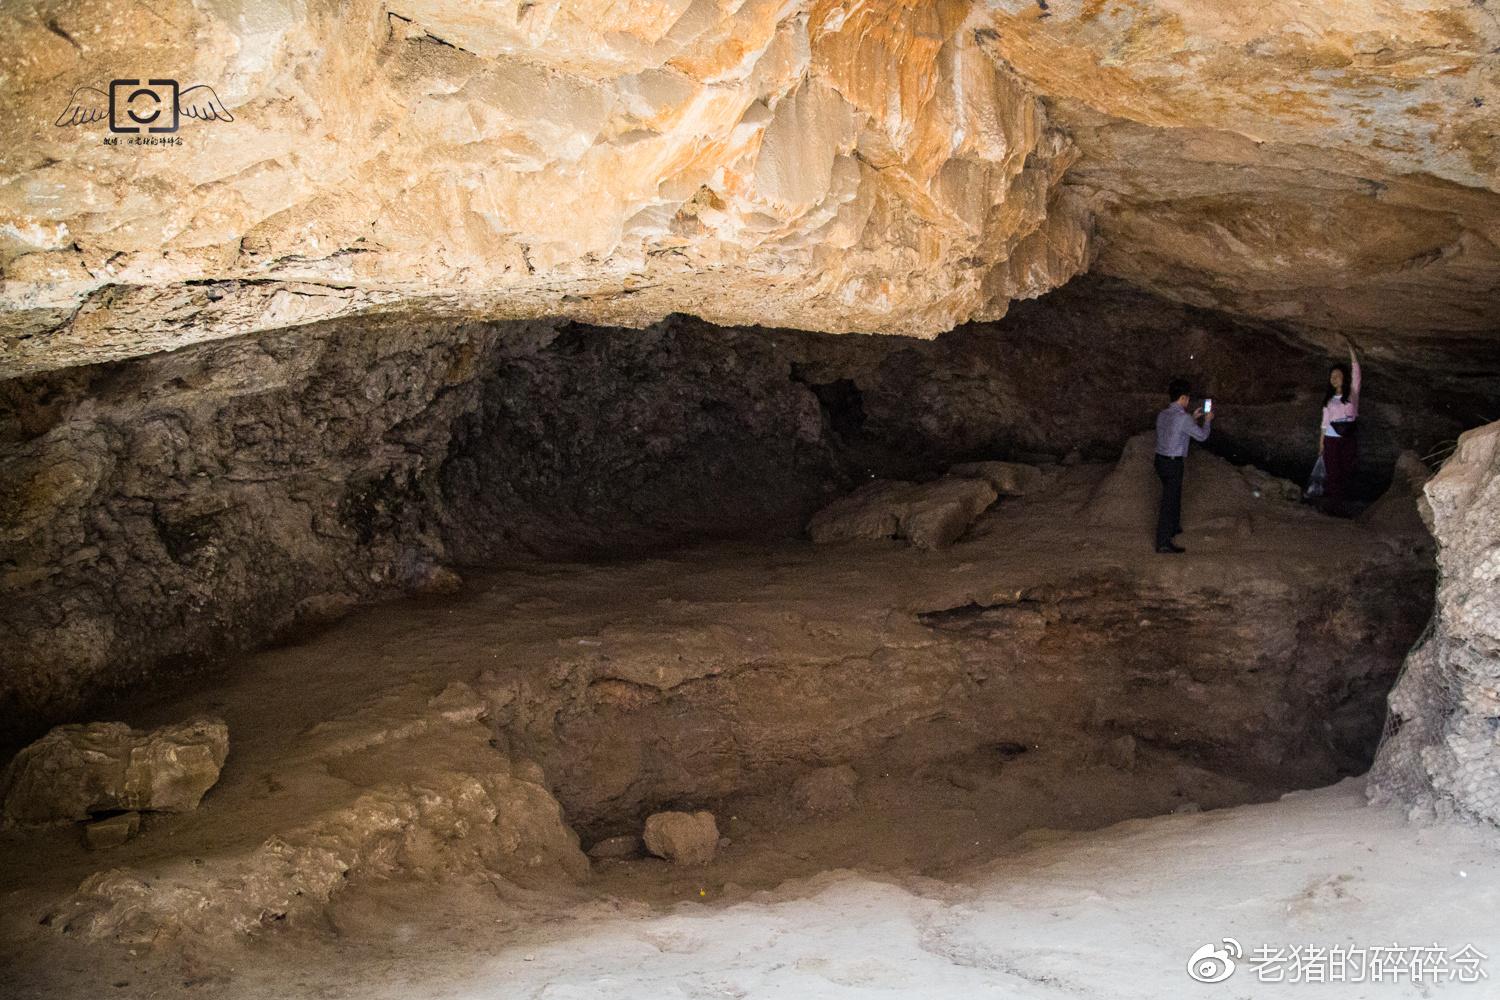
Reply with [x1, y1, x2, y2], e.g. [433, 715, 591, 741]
[0, 322, 534, 739]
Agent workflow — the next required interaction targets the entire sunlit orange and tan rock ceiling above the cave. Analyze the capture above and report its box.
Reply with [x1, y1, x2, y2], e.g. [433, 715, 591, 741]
[0, 0, 1500, 376]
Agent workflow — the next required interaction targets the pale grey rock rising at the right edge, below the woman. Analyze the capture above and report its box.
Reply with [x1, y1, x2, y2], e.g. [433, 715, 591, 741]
[1370, 423, 1500, 823]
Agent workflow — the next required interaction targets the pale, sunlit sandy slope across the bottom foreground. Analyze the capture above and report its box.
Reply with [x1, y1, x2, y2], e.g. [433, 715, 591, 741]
[258, 781, 1500, 1000]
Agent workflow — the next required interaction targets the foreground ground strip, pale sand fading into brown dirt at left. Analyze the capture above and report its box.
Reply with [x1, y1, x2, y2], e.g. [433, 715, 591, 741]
[12, 780, 1500, 1000]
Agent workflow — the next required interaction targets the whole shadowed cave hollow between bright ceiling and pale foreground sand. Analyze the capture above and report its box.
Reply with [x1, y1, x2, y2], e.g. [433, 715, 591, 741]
[0, 279, 1464, 993]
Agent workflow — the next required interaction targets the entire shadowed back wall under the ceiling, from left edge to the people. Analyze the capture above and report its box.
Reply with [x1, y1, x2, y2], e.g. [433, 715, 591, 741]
[0, 279, 1472, 739]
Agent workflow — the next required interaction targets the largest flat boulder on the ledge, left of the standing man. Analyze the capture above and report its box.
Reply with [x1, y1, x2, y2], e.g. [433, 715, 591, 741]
[807, 477, 998, 550]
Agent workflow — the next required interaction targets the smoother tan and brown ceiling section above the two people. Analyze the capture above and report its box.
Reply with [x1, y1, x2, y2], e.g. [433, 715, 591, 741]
[984, 0, 1500, 334]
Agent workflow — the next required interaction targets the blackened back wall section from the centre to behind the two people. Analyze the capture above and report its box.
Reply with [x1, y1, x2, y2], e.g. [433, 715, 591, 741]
[444, 277, 1500, 559]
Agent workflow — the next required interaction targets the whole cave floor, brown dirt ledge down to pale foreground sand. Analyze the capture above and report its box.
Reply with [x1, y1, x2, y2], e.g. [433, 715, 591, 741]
[0, 458, 1446, 999]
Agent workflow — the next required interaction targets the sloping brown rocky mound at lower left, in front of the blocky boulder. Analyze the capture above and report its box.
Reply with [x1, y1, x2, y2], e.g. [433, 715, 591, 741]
[35, 682, 588, 949]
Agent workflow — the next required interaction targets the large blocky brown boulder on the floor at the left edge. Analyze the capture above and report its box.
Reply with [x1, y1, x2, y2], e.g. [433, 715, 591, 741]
[0, 718, 230, 823]
